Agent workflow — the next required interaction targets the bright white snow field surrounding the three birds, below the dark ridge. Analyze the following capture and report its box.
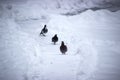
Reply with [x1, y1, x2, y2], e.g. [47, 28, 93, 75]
[0, 0, 120, 80]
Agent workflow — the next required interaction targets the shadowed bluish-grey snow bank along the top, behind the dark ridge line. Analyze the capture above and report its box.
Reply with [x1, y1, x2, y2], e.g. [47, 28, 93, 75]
[0, 0, 120, 15]
